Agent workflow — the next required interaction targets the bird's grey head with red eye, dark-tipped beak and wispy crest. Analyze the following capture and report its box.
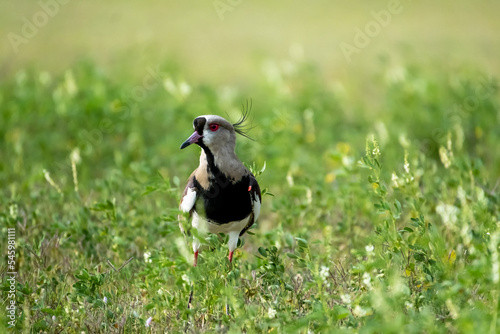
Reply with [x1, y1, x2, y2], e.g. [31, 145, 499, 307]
[181, 114, 252, 153]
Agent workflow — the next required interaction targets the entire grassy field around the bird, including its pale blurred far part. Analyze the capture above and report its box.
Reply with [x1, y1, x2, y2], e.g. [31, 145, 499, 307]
[0, 1, 500, 333]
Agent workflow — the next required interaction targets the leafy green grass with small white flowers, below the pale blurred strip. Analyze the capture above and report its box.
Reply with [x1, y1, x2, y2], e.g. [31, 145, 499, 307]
[0, 58, 500, 333]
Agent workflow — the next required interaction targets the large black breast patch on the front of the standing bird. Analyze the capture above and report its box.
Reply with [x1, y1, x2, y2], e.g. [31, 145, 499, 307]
[194, 173, 252, 224]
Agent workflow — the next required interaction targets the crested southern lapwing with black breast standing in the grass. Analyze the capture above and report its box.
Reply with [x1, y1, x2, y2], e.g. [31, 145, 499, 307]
[180, 114, 261, 266]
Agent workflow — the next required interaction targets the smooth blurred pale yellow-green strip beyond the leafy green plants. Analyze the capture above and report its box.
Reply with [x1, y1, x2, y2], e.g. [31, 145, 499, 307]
[0, 0, 500, 87]
